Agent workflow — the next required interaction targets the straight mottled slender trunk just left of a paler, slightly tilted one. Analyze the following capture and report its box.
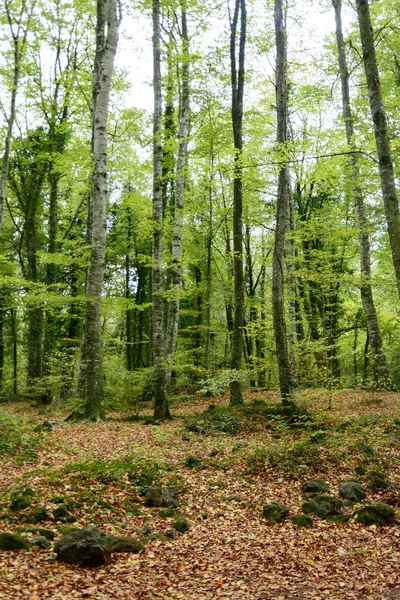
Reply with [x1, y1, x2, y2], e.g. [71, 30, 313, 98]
[151, 0, 171, 420]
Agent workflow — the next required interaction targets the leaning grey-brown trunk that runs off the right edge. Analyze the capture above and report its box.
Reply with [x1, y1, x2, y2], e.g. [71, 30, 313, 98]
[356, 0, 400, 300]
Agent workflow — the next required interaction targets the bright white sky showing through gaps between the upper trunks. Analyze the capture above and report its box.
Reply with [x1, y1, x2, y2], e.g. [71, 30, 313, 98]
[116, 0, 354, 111]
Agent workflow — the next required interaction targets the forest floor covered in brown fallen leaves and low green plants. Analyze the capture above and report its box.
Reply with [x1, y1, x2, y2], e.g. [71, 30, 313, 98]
[0, 390, 400, 600]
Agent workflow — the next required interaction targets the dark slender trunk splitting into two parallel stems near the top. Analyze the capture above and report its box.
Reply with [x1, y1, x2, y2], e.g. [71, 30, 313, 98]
[230, 0, 247, 405]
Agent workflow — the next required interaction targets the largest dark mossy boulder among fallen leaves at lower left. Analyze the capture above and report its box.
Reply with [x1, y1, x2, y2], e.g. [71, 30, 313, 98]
[54, 527, 112, 567]
